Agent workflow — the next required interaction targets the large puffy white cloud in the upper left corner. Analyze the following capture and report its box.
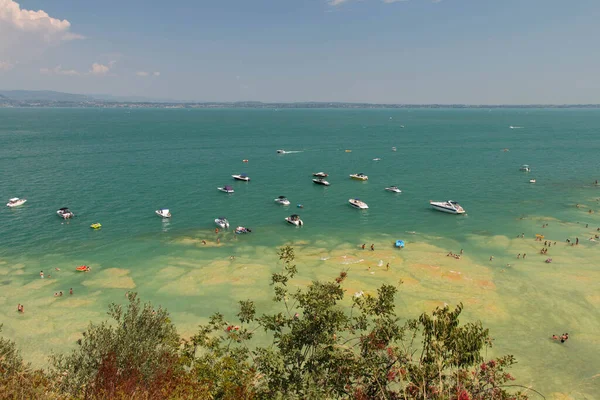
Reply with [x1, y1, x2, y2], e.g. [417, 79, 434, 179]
[0, 0, 83, 41]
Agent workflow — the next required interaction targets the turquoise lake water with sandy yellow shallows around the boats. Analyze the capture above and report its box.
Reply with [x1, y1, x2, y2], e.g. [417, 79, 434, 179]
[0, 109, 600, 399]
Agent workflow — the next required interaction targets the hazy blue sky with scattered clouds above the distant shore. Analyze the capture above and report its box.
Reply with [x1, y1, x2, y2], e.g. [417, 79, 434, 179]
[0, 0, 600, 104]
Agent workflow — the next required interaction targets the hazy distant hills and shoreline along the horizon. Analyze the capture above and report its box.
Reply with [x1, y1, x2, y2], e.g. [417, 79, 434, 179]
[0, 90, 600, 109]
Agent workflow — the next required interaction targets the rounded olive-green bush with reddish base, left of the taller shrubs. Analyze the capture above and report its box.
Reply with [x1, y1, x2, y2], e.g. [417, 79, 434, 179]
[52, 293, 181, 397]
